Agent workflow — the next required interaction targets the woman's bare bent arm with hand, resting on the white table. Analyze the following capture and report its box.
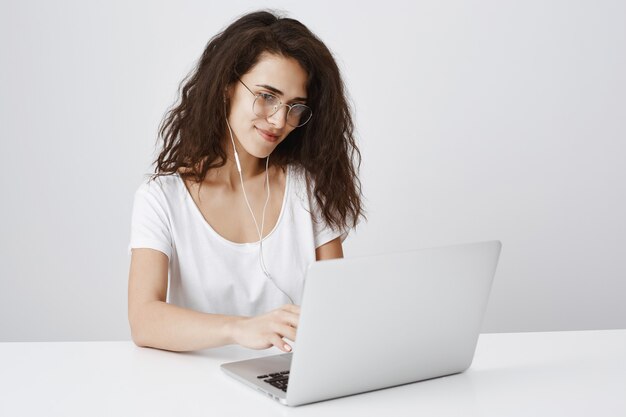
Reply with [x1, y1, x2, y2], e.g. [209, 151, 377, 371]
[128, 248, 298, 352]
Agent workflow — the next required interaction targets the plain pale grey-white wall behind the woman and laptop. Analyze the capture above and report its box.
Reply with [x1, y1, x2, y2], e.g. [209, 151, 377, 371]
[0, 0, 626, 341]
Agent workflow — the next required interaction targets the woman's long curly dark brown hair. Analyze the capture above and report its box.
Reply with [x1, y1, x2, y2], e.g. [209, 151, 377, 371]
[155, 11, 365, 230]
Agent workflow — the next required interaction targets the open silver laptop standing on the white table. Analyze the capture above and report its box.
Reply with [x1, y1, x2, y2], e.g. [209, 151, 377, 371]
[221, 241, 501, 406]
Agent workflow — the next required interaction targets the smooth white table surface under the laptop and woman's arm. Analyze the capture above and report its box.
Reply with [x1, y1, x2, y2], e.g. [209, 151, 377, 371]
[0, 330, 626, 417]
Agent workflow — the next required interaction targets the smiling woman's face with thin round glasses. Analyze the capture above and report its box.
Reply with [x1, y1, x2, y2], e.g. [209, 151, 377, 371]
[228, 53, 307, 158]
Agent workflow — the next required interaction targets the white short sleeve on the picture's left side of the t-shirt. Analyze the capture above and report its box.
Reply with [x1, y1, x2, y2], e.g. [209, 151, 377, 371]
[128, 181, 172, 258]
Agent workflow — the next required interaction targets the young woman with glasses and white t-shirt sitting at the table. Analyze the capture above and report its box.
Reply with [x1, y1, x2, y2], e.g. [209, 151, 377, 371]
[128, 12, 363, 352]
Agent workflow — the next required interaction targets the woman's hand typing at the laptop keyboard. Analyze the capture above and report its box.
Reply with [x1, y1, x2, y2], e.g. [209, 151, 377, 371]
[232, 304, 300, 352]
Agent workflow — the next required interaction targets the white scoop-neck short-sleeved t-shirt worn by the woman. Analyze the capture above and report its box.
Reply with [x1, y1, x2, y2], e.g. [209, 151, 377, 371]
[129, 167, 347, 316]
